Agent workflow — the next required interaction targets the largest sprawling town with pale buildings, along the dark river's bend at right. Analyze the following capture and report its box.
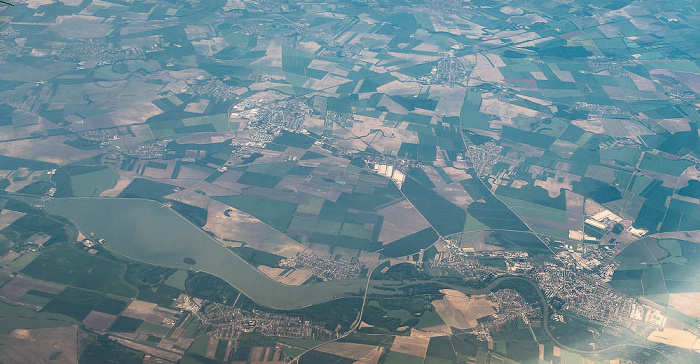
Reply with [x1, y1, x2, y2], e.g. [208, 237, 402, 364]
[430, 239, 666, 335]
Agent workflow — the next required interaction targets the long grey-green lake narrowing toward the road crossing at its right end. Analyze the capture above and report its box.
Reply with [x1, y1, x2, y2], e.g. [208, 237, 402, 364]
[46, 197, 366, 310]
